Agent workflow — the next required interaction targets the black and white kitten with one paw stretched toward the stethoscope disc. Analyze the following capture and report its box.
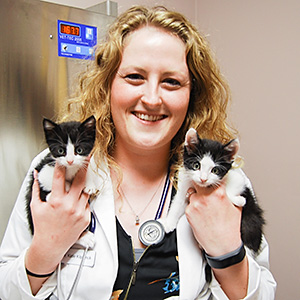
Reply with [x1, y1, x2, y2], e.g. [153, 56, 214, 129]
[160, 128, 265, 268]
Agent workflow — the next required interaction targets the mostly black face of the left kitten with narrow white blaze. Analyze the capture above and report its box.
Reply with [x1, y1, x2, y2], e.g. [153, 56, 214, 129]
[44, 117, 95, 168]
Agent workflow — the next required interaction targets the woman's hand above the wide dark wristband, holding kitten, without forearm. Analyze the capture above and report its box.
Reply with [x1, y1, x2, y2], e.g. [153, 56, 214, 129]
[186, 180, 242, 256]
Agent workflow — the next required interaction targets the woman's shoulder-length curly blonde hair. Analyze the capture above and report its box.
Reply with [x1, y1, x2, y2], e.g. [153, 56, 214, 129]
[67, 6, 234, 176]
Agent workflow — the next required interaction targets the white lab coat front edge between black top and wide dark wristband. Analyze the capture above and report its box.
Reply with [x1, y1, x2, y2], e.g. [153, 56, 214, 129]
[177, 216, 205, 300]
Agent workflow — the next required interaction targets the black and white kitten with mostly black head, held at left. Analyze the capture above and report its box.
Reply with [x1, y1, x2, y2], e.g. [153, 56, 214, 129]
[26, 116, 97, 234]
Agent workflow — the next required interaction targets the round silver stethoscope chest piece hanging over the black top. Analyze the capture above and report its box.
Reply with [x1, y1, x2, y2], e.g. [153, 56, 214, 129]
[139, 220, 165, 246]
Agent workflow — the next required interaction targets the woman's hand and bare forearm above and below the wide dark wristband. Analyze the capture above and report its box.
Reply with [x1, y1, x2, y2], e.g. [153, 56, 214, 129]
[186, 183, 248, 299]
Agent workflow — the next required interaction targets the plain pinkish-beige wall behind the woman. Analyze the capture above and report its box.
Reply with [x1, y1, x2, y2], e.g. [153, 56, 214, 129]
[10, 0, 300, 300]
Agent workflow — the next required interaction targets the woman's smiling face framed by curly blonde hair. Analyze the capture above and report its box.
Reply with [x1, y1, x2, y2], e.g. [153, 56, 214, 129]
[111, 26, 190, 157]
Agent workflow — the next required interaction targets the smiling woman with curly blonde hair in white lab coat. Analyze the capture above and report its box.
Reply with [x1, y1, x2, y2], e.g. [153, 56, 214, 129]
[0, 7, 276, 300]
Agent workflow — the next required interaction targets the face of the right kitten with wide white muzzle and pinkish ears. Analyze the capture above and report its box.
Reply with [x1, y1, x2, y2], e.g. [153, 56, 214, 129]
[184, 129, 239, 187]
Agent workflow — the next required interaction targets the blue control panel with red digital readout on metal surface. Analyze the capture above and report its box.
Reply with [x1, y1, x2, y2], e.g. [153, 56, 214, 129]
[57, 20, 97, 59]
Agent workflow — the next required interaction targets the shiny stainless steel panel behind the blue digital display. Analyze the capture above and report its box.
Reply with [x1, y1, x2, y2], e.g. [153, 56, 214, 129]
[0, 0, 114, 240]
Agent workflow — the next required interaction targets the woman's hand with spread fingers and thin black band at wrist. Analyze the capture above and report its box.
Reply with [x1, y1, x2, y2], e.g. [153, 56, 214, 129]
[25, 164, 90, 293]
